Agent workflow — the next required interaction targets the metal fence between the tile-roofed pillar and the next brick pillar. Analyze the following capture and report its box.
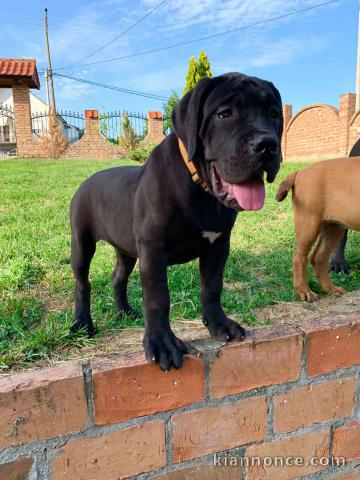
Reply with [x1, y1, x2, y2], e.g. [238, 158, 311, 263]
[31, 110, 85, 143]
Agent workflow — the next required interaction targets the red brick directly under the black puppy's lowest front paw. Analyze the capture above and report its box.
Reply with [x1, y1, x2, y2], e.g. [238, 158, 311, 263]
[93, 354, 205, 425]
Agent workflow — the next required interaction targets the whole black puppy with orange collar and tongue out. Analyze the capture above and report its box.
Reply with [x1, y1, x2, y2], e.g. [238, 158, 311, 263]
[71, 73, 283, 371]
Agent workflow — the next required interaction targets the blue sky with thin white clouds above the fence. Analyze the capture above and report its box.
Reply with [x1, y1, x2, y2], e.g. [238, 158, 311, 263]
[1, 0, 358, 112]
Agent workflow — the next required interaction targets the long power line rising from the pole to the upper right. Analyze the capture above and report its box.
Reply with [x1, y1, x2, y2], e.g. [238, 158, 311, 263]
[54, 0, 339, 71]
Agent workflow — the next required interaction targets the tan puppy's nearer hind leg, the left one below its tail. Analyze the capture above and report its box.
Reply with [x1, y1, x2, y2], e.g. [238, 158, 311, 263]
[293, 213, 320, 302]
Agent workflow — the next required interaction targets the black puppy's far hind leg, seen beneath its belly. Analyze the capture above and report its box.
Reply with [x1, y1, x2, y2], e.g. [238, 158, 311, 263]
[111, 249, 139, 318]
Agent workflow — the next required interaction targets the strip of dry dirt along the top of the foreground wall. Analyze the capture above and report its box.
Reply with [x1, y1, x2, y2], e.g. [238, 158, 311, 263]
[28, 290, 360, 368]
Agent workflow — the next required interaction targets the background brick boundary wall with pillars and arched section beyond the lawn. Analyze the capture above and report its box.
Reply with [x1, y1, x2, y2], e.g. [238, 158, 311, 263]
[13, 85, 360, 161]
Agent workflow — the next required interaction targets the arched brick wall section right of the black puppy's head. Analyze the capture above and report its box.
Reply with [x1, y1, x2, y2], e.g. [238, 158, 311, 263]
[282, 93, 360, 161]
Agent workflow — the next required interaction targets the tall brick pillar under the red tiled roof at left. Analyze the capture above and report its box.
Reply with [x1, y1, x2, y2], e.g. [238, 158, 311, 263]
[12, 85, 34, 157]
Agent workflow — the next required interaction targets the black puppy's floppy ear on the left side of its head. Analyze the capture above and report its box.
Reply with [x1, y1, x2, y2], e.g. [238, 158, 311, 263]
[171, 77, 215, 160]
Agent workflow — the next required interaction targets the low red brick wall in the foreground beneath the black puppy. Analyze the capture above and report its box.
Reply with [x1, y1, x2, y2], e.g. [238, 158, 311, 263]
[0, 314, 360, 480]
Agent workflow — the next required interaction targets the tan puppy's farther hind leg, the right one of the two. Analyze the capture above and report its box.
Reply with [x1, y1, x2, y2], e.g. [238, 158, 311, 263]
[310, 223, 346, 295]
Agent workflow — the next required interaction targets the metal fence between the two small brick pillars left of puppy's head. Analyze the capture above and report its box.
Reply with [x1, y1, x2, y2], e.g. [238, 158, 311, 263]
[100, 111, 148, 144]
